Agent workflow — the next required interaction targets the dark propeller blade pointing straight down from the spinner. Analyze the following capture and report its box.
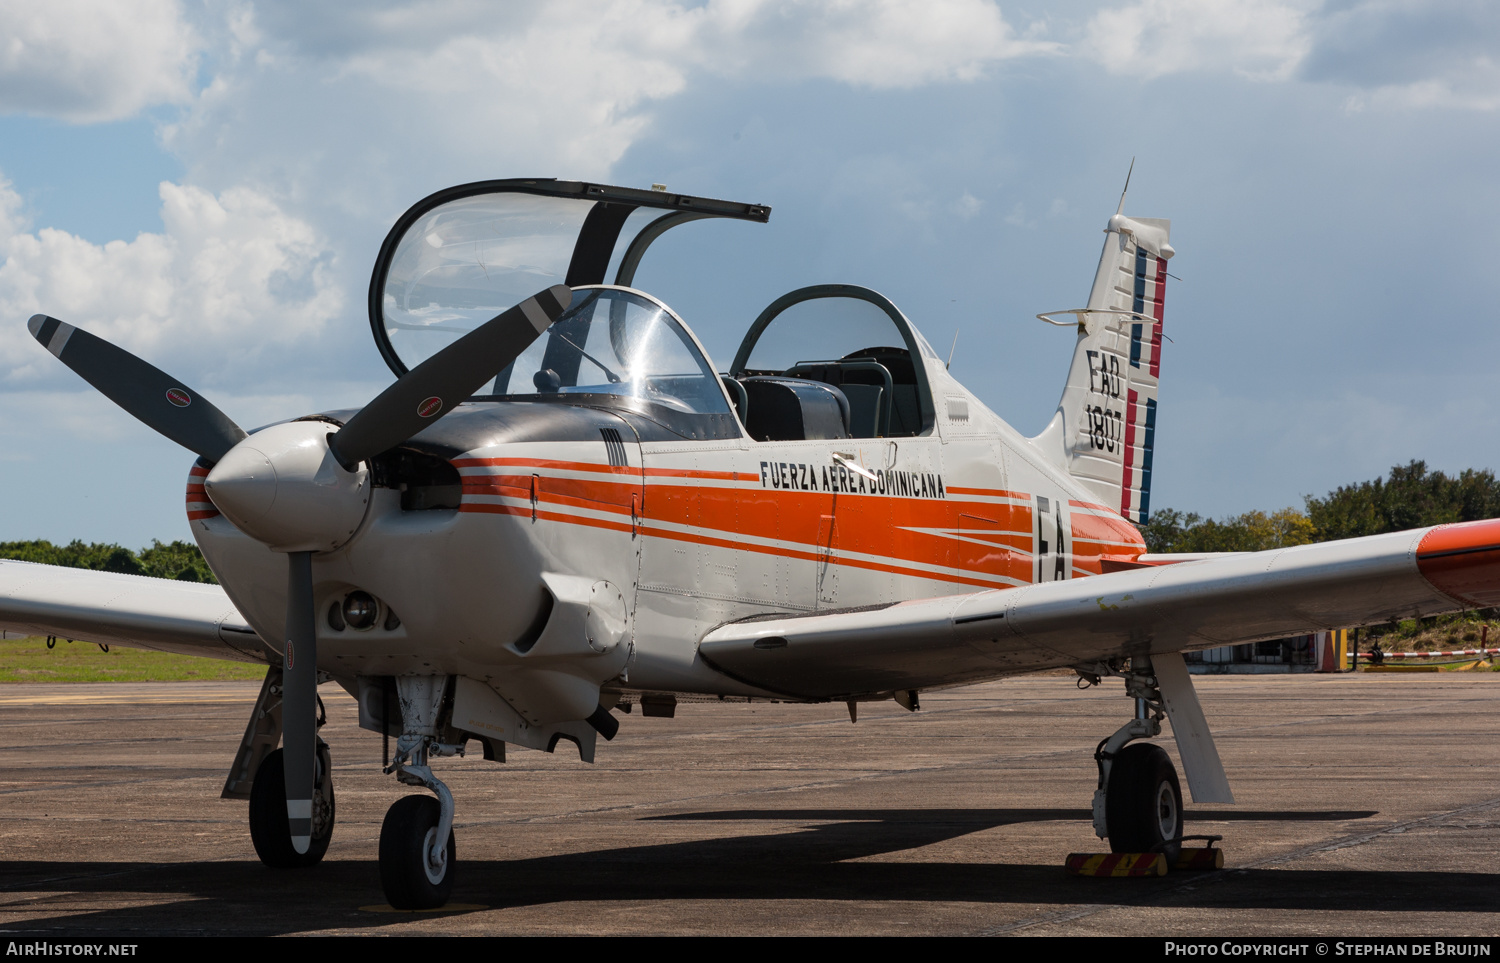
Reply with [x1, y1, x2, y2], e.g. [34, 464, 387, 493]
[282, 552, 318, 854]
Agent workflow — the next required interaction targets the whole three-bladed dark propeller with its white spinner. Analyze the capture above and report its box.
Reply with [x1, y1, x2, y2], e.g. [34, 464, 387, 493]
[36, 285, 573, 854]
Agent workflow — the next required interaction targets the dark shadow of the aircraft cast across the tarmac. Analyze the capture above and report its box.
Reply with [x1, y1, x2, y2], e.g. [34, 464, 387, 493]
[0, 809, 1496, 936]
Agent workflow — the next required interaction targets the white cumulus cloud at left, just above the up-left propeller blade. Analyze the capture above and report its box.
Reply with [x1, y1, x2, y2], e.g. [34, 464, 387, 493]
[0, 182, 344, 387]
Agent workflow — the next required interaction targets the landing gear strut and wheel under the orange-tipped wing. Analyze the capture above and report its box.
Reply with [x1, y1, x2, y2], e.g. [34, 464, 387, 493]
[1094, 660, 1182, 866]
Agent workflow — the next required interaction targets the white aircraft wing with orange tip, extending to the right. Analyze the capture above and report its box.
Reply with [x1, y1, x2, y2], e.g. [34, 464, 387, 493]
[699, 519, 1500, 699]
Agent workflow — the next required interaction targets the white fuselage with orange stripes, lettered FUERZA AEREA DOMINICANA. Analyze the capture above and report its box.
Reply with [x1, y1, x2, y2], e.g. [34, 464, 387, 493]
[189, 300, 1145, 698]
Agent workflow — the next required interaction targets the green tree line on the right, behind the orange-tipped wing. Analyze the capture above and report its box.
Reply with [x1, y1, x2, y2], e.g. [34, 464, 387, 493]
[1142, 461, 1500, 552]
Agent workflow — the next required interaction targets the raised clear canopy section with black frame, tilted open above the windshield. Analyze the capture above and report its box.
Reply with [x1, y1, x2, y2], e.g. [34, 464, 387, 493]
[369, 179, 771, 378]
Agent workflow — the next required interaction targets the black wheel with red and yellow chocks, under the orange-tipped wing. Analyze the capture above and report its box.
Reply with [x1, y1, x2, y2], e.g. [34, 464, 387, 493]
[1104, 743, 1182, 864]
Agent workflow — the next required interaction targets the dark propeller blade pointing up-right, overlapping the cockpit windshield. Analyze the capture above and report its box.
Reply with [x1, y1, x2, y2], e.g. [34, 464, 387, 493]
[330, 285, 573, 467]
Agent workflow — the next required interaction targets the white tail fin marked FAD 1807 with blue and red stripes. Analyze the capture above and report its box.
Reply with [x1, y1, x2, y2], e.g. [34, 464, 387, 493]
[1032, 215, 1175, 524]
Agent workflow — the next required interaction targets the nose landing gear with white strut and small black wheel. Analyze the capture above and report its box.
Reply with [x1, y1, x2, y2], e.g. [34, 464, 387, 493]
[380, 675, 464, 909]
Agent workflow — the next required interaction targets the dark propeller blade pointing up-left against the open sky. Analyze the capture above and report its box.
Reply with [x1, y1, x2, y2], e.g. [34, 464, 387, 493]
[26, 315, 245, 462]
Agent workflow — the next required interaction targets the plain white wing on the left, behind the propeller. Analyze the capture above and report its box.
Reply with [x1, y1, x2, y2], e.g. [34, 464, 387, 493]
[0, 561, 266, 663]
